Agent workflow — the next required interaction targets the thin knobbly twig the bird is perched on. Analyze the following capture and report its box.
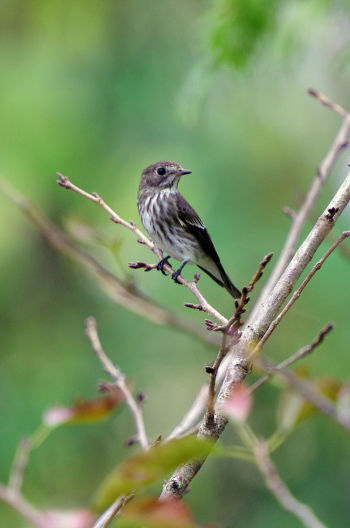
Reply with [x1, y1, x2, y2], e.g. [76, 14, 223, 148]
[57, 173, 227, 324]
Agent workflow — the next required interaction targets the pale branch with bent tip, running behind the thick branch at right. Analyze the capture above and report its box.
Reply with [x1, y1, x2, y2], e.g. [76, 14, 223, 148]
[252, 90, 350, 312]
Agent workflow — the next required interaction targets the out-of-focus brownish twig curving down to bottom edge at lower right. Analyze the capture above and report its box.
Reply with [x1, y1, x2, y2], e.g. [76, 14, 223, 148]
[254, 441, 326, 528]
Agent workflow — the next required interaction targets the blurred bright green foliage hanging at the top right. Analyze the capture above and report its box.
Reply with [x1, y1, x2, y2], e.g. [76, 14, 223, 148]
[208, 0, 349, 70]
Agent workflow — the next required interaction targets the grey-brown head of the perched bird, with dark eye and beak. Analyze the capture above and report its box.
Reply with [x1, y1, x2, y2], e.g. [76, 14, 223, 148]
[141, 161, 192, 194]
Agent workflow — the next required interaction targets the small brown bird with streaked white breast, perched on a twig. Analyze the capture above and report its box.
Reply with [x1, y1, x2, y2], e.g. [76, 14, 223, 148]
[137, 161, 241, 299]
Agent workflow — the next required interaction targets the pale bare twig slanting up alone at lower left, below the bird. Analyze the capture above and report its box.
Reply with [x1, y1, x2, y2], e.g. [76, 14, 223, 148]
[86, 317, 149, 450]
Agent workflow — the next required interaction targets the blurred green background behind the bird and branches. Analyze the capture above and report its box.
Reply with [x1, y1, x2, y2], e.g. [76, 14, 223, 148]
[0, 0, 350, 528]
